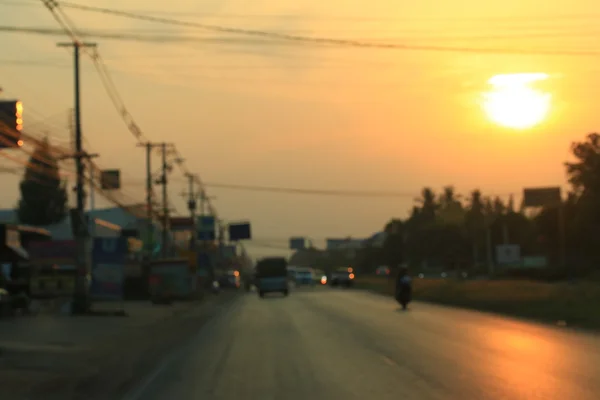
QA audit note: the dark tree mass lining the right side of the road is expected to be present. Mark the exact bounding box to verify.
[356,133,600,279]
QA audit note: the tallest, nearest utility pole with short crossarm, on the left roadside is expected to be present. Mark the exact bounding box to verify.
[58,41,96,314]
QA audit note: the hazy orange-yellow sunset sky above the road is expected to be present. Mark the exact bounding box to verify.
[0,0,600,253]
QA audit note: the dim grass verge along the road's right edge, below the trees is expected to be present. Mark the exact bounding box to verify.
[356,276,600,330]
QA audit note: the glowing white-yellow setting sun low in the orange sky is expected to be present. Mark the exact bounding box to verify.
[481,73,552,129]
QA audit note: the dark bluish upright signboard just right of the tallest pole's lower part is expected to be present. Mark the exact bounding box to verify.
[90,237,129,300]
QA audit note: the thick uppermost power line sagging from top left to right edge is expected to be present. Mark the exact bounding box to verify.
[51,2,600,56]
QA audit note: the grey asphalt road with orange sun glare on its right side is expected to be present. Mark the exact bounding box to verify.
[127,289,600,400]
